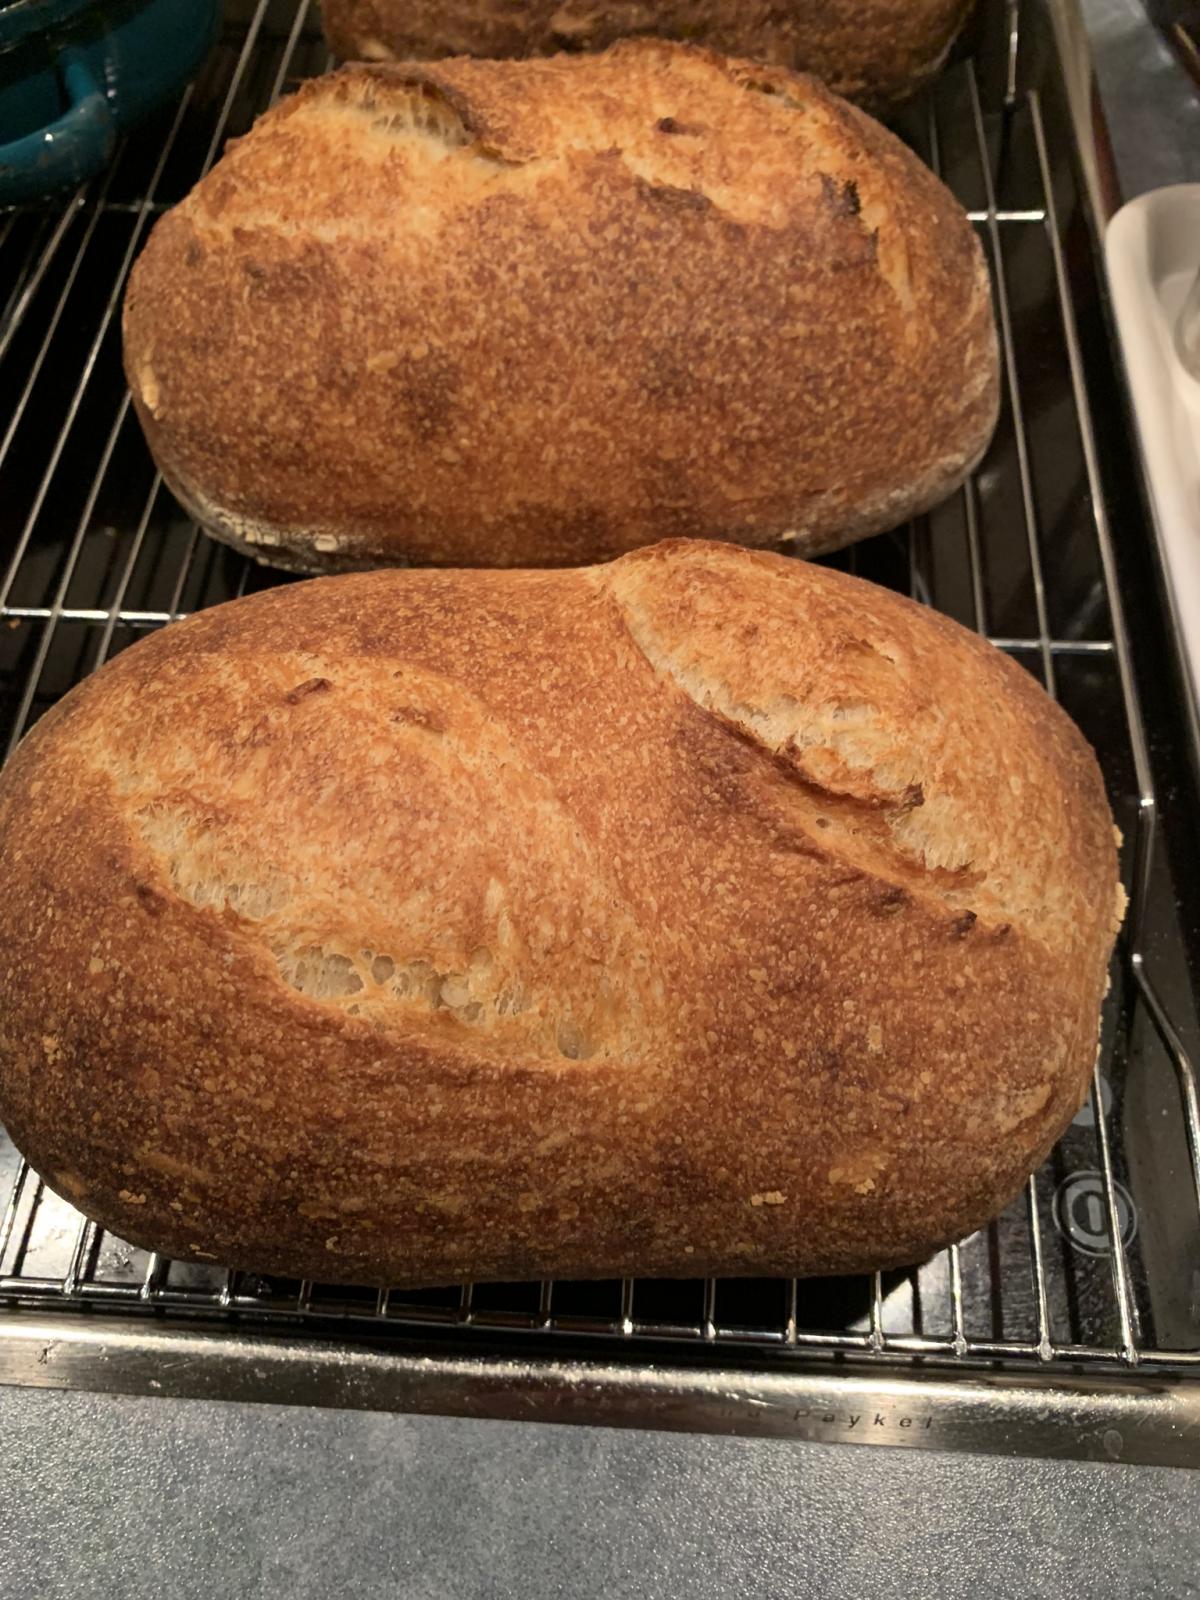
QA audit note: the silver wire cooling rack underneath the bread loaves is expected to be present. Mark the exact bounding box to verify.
[0,0,1200,1371]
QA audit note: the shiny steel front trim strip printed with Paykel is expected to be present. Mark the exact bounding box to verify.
[0,1310,1200,1469]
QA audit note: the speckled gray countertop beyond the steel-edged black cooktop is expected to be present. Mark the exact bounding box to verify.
[0,0,1200,1600]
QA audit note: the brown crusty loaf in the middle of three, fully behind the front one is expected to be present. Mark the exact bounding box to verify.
[125,42,998,571]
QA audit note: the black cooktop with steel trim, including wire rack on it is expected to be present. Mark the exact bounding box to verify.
[0,0,1200,1466]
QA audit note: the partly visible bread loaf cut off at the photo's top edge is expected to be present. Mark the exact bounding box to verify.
[322,0,971,106]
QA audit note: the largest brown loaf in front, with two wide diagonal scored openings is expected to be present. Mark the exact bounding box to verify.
[0,542,1122,1283]
